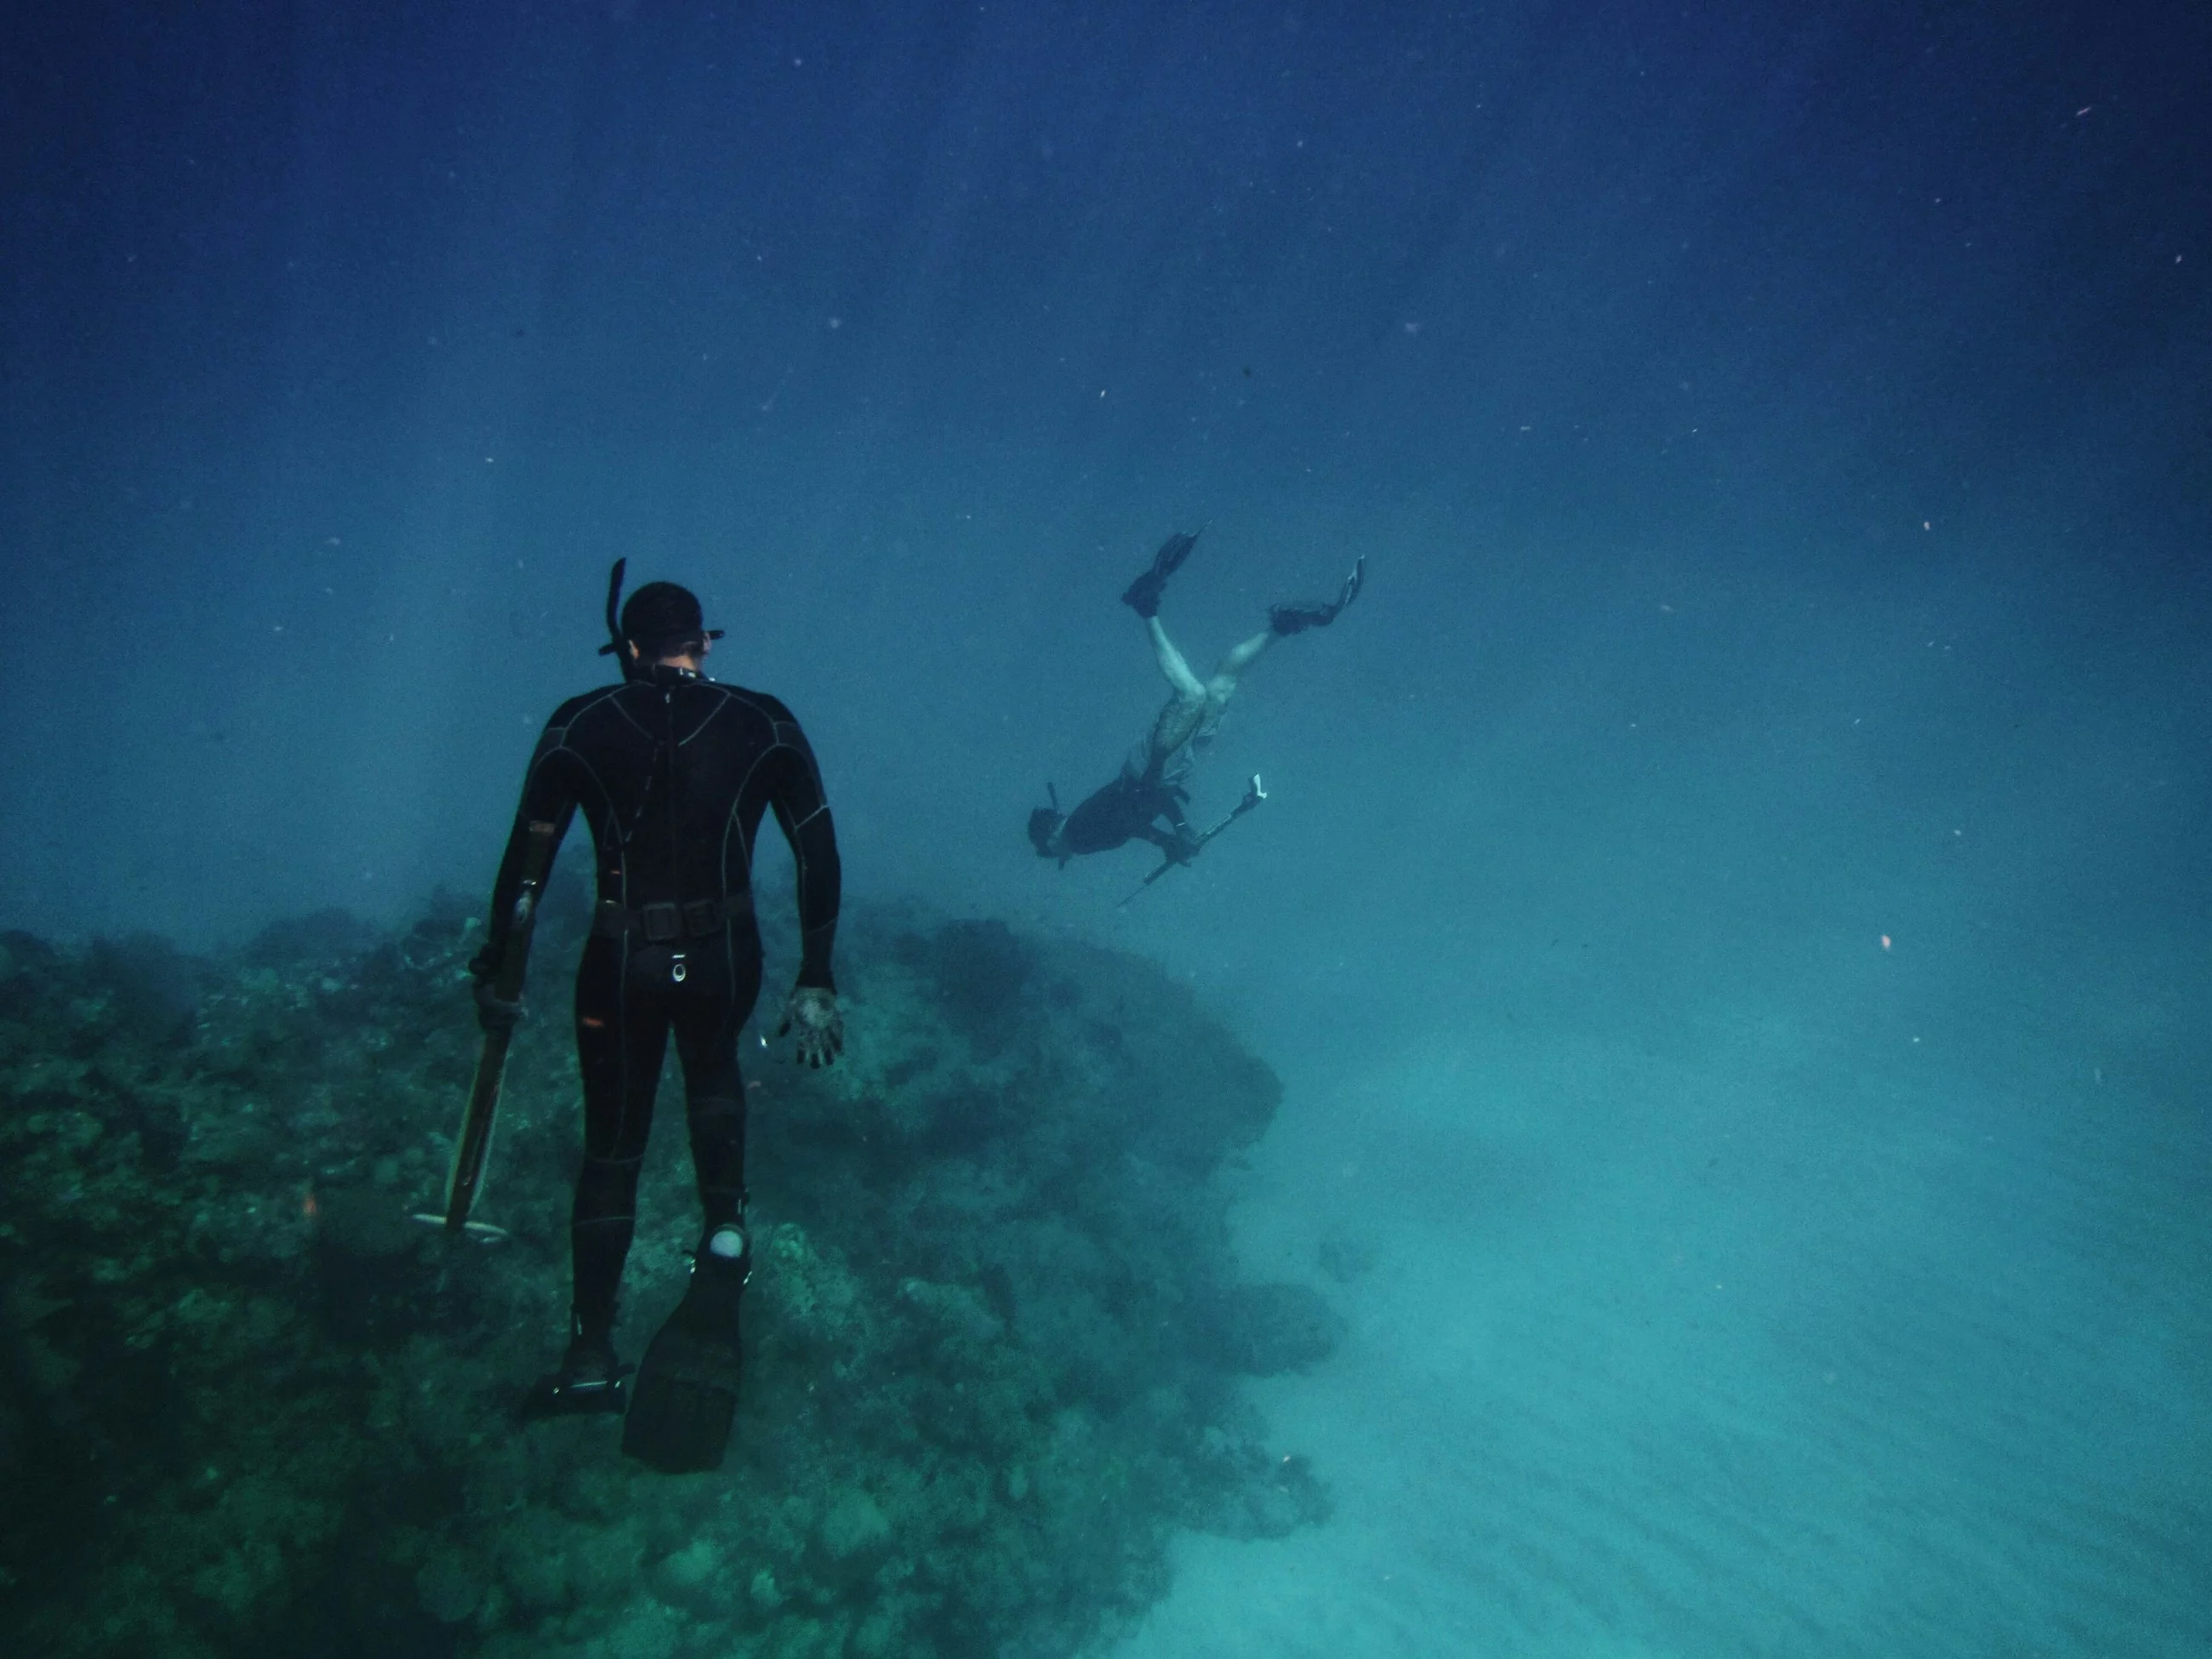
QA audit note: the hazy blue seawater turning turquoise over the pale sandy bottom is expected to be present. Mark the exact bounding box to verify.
[0,0,2212,1659]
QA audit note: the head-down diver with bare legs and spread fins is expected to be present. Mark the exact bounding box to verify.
[1029,531,1367,874]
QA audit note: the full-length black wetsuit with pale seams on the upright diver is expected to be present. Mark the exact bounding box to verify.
[476,666,838,1336]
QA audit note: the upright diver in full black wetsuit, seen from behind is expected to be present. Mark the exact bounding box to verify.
[469,562,843,1471]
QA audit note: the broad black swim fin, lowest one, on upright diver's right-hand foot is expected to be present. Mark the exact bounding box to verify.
[622,1241,752,1475]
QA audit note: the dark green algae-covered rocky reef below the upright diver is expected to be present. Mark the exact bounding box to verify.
[0,900,1338,1659]
